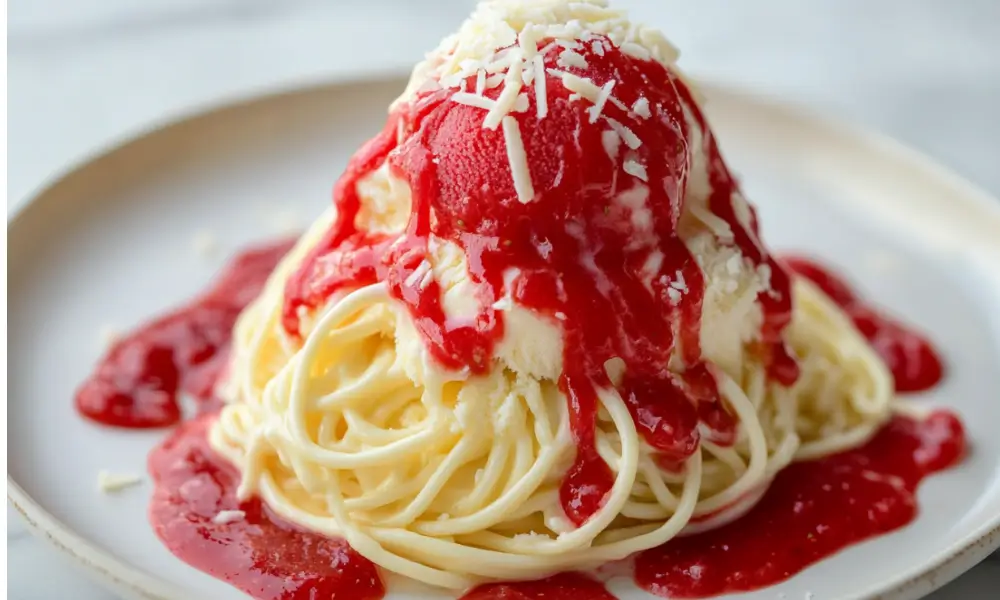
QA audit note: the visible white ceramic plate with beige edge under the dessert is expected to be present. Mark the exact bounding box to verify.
[7,80,1000,599]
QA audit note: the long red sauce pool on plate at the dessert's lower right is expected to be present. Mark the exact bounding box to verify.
[635,411,965,598]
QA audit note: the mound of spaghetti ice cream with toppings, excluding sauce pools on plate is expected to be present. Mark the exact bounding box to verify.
[209,0,893,589]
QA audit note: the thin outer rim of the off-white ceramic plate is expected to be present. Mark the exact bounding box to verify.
[7,75,1000,600]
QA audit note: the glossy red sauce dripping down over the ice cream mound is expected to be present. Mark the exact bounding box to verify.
[283,36,798,525]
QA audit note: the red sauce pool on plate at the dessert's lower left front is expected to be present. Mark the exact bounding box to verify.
[149,413,385,600]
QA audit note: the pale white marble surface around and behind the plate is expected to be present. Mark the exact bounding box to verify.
[7,0,1000,600]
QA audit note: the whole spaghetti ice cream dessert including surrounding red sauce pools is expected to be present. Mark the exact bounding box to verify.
[68,0,965,600]
